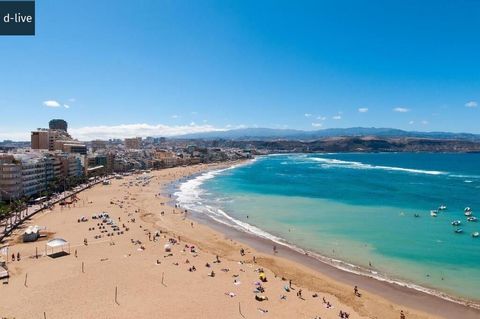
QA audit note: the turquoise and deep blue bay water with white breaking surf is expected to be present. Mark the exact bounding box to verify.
[177,153,480,301]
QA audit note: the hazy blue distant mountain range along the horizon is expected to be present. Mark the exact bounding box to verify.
[174,127,480,142]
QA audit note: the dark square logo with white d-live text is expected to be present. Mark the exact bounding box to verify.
[0,0,35,35]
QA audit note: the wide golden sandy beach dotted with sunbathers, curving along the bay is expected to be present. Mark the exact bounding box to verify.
[0,163,479,319]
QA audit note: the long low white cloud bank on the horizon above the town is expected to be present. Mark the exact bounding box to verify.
[69,123,225,141]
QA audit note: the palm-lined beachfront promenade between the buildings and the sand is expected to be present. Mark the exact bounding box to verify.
[0,175,114,242]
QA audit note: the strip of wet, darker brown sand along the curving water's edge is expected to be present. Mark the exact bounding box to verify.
[172,161,480,319]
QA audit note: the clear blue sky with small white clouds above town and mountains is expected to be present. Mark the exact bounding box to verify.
[0,0,480,139]
